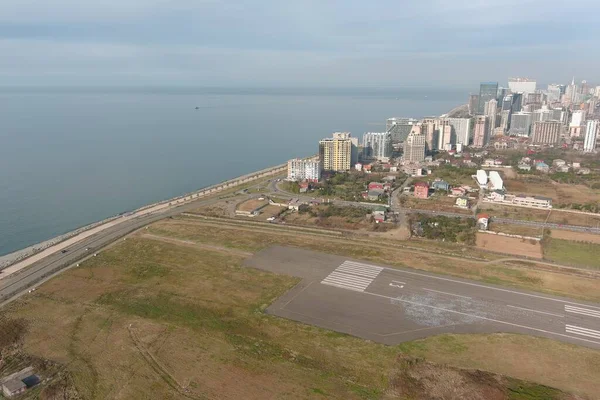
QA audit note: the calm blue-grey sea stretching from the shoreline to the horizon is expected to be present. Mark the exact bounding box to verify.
[0,89,467,255]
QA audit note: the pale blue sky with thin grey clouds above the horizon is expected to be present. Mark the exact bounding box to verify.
[0,0,600,87]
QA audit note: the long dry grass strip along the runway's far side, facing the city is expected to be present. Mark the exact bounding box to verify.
[150,220,600,301]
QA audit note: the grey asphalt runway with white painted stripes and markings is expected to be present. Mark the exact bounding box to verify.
[246,247,600,349]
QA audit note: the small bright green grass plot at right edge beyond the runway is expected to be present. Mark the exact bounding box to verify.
[544,238,600,268]
